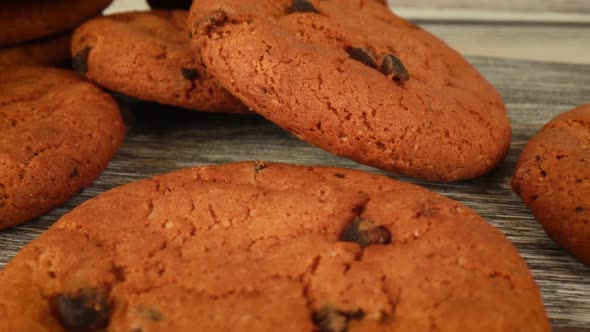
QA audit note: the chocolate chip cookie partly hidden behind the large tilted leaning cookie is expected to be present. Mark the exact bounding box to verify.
[72,10,248,112]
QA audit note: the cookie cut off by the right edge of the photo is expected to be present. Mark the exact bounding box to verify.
[512,104,590,265]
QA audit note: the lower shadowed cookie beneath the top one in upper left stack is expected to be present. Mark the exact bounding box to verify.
[0,33,72,66]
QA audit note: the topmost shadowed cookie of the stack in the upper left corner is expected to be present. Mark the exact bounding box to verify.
[0,0,112,46]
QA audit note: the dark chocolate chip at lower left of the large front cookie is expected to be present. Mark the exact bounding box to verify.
[56,289,110,332]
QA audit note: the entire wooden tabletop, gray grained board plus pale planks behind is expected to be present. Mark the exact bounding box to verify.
[0,0,590,332]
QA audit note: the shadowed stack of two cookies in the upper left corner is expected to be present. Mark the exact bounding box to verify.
[0,0,112,66]
